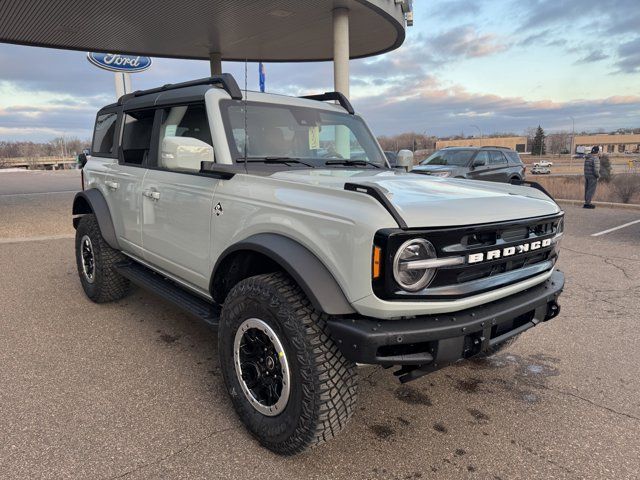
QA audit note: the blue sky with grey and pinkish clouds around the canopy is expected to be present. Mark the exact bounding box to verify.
[0,0,640,141]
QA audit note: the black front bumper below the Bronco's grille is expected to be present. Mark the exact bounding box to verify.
[328,271,564,381]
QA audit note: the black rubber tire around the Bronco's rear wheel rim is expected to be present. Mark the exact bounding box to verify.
[76,214,131,303]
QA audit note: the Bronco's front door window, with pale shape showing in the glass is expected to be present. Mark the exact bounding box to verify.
[157,104,213,172]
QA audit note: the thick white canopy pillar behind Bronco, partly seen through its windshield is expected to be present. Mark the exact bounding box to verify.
[333,8,351,158]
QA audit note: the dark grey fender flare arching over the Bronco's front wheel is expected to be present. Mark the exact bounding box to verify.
[211,233,355,315]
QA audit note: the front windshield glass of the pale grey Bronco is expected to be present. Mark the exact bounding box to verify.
[221,100,386,168]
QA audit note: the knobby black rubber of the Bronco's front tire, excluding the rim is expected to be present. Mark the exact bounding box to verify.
[218,273,358,455]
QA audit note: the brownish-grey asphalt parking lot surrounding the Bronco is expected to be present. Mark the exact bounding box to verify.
[0,171,640,479]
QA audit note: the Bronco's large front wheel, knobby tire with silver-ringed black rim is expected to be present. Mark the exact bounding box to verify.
[218,273,357,455]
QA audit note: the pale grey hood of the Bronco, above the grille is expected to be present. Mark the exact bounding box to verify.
[272,169,560,228]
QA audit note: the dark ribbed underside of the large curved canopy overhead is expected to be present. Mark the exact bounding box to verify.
[0,0,405,62]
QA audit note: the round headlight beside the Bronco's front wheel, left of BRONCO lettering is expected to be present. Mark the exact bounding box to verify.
[393,238,436,292]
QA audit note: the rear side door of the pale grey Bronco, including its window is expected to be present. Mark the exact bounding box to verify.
[105,109,155,256]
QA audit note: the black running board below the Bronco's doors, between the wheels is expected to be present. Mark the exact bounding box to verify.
[116,261,220,328]
